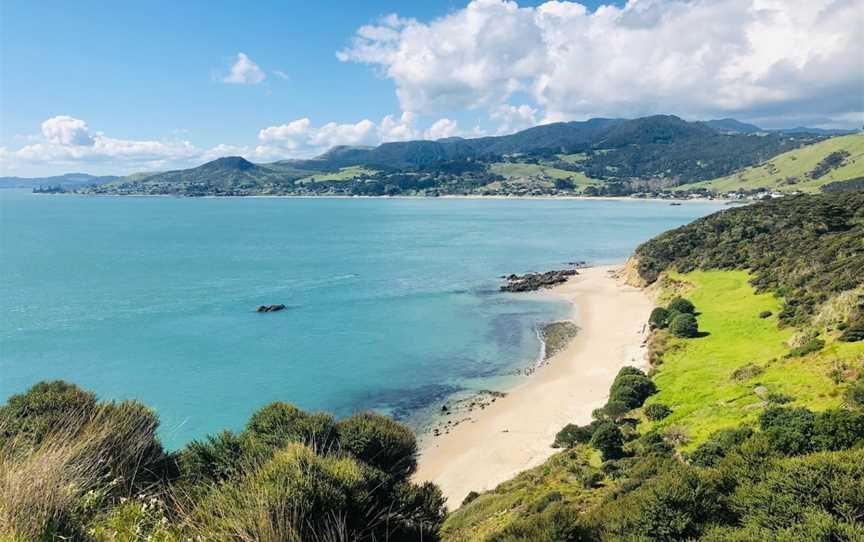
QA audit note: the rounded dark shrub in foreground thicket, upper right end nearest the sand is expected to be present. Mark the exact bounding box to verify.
[338,412,417,479]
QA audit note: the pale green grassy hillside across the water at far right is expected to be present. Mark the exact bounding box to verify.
[677,133,864,192]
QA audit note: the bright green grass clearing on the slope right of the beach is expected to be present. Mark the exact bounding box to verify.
[641,271,864,449]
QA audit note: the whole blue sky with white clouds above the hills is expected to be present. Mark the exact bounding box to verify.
[0,0,864,176]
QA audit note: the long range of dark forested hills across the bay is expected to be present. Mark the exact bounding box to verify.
[10,115,860,196]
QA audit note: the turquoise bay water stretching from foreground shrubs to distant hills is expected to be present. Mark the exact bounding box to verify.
[0,190,721,447]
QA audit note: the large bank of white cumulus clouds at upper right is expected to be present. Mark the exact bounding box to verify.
[337,0,864,129]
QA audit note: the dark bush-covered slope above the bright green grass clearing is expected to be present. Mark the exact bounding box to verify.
[636,191,864,325]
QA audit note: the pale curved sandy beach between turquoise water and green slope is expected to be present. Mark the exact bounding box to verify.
[415,266,652,509]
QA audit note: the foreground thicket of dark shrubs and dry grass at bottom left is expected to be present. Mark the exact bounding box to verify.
[0,381,444,542]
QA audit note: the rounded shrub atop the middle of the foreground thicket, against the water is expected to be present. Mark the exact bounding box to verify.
[246,401,336,452]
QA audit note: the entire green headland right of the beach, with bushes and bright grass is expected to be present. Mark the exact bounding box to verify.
[442,193,864,542]
